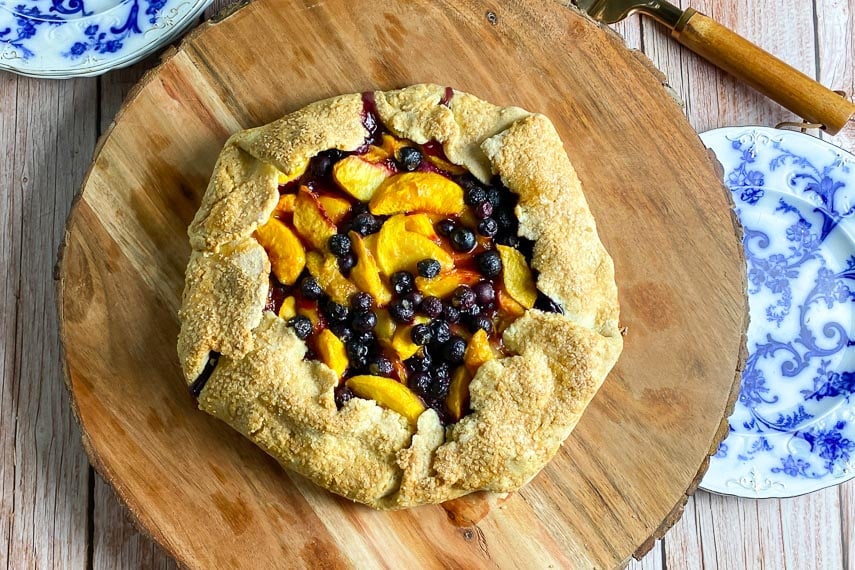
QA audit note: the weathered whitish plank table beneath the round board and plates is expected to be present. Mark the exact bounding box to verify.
[0,0,855,570]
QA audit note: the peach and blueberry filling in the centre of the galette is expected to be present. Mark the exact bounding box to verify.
[255,96,561,425]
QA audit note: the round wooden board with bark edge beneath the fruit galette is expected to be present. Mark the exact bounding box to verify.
[59,0,746,568]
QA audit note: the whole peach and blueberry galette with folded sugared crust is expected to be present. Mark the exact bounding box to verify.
[178,85,622,509]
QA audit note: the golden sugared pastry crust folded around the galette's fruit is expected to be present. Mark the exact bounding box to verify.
[178,85,622,509]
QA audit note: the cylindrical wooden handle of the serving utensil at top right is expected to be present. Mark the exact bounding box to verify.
[671,8,855,134]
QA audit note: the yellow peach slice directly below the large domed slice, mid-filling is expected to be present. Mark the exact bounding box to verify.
[377,215,454,276]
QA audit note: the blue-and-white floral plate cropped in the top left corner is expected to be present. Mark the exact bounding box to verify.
[0,0,211,79]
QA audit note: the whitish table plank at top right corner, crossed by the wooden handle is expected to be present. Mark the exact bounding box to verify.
[816,0,855,152]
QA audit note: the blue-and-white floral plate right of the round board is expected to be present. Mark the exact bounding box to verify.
[701,127,855,498]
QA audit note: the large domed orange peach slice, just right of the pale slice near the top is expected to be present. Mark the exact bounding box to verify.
[369,172,466,215]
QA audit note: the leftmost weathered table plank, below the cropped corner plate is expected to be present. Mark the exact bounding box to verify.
[0,76,96,568]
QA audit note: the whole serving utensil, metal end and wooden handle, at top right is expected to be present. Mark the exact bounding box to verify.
[571,0,855,135]
